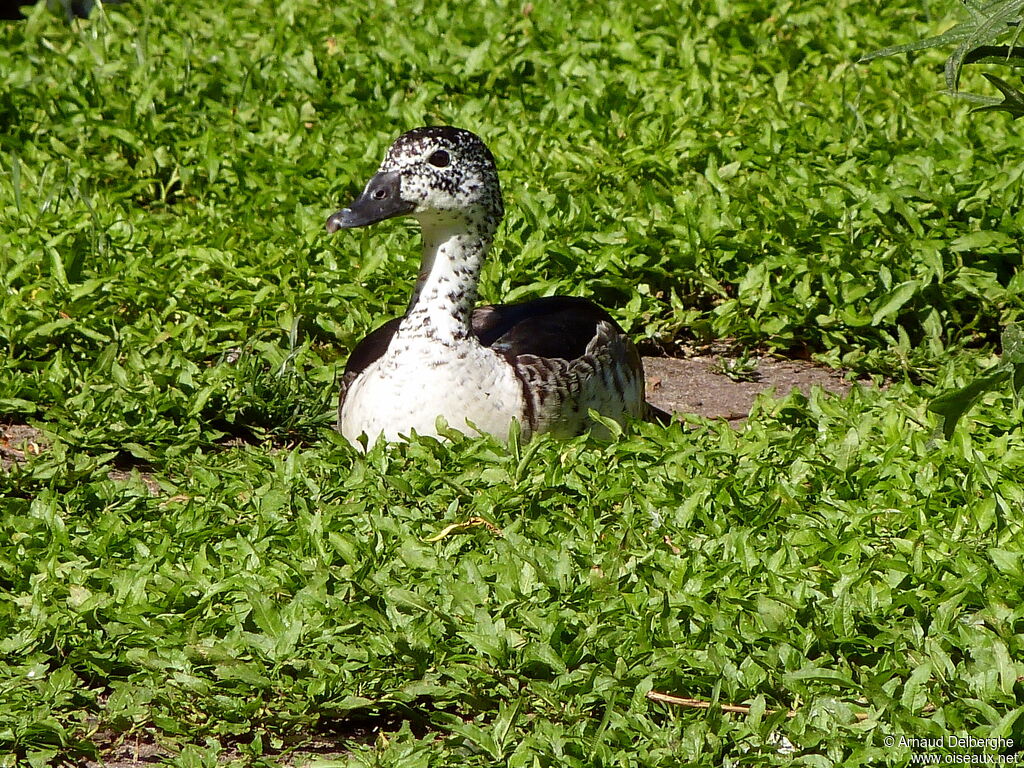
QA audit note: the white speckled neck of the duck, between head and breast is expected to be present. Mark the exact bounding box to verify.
[401,219,492,343]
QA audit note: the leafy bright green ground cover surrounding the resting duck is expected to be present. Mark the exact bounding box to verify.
[0,0,1024,766]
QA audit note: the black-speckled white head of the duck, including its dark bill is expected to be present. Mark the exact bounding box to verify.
[327,126,504,234]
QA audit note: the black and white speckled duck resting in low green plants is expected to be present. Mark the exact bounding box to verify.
[327,126,667,444]
